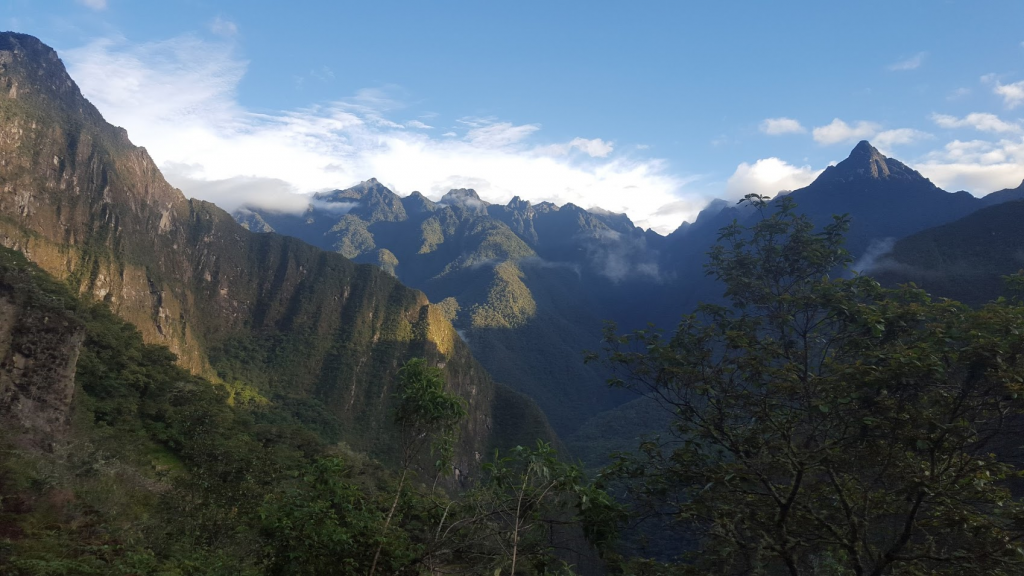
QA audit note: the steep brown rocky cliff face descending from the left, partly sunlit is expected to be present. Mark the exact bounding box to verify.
[0,33,552,465]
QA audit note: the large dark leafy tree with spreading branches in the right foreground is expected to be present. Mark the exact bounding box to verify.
[605,195,1024,576]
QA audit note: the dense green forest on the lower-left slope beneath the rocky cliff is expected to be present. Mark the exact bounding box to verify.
[0,243,608,576]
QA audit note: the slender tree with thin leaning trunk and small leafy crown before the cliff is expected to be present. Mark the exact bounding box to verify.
[370,358,466,576]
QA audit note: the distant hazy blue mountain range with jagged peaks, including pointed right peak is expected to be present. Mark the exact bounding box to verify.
[234,136,1024,454]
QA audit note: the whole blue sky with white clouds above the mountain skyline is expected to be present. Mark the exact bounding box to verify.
[6,0,1024,232]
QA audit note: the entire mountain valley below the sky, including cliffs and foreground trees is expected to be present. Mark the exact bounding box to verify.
[0,33,1024,576]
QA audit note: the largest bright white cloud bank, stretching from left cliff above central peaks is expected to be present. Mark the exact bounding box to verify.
[63,36,706,232]
